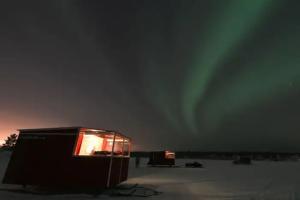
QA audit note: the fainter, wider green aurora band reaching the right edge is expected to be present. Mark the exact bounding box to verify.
[204,35,300,129]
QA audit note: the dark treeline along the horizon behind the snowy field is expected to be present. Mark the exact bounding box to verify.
[131,151,300,161]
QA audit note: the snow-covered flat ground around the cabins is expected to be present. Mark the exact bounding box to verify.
[0,152,300,200]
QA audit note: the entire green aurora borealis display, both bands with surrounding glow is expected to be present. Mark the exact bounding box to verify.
[144,0,300,138]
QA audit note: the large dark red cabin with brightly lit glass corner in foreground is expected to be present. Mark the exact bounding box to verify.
[3,127,130,188]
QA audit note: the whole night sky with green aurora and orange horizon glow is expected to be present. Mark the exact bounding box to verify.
[0,0,300,151]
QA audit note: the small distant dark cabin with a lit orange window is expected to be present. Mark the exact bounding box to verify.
[148,151,175,166]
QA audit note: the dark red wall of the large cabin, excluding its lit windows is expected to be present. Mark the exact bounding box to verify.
[3,131,129,188]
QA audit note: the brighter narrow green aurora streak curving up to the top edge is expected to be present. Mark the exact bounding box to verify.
[182,0,272,132]
